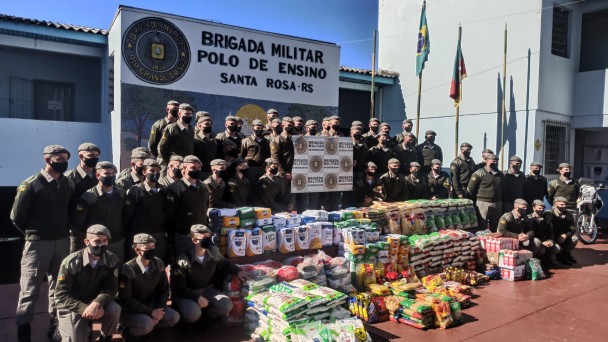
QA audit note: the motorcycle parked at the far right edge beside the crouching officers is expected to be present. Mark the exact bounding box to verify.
[576,179,605,244]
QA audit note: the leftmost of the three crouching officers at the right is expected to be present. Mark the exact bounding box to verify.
[497,198,541,255]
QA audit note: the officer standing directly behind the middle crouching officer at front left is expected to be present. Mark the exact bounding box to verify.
[125,159,167,260]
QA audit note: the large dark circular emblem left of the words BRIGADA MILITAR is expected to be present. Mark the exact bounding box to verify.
[122,17,190,84]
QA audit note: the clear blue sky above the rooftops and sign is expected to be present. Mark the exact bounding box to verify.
[0,0,378,69]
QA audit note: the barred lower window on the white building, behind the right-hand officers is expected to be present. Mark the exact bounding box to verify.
[543,120,570,175]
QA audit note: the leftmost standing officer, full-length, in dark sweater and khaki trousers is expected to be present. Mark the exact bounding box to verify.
[11,145,74,341]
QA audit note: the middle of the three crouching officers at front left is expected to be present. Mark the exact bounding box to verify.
[116,233,179,342]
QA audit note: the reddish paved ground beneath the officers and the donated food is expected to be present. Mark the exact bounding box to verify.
[0,231,608,342]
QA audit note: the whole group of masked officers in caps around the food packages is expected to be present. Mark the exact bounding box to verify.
[11,101,579,341]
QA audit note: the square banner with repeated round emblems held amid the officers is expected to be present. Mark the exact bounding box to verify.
[291,136,353,193]
